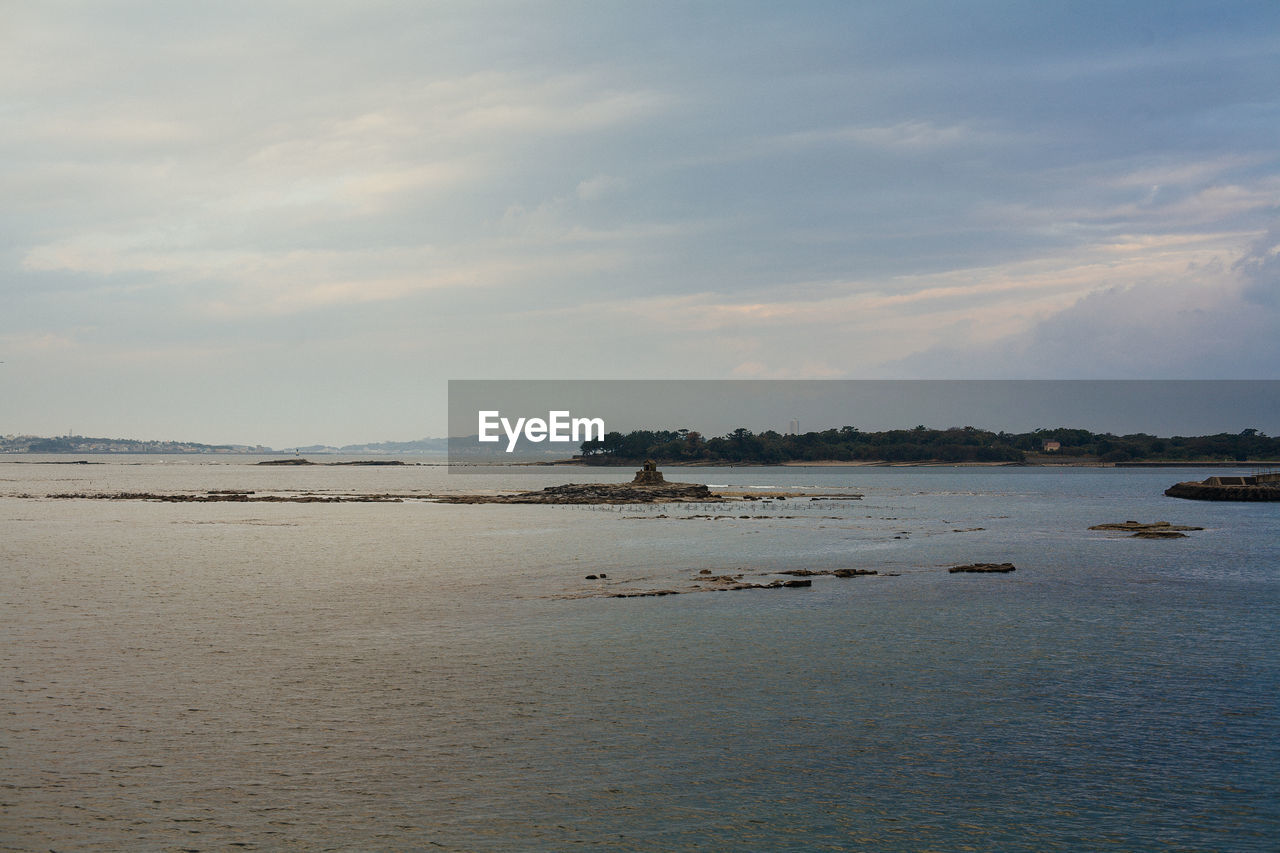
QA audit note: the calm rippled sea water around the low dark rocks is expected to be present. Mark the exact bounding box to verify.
[0,457,1280,852]
